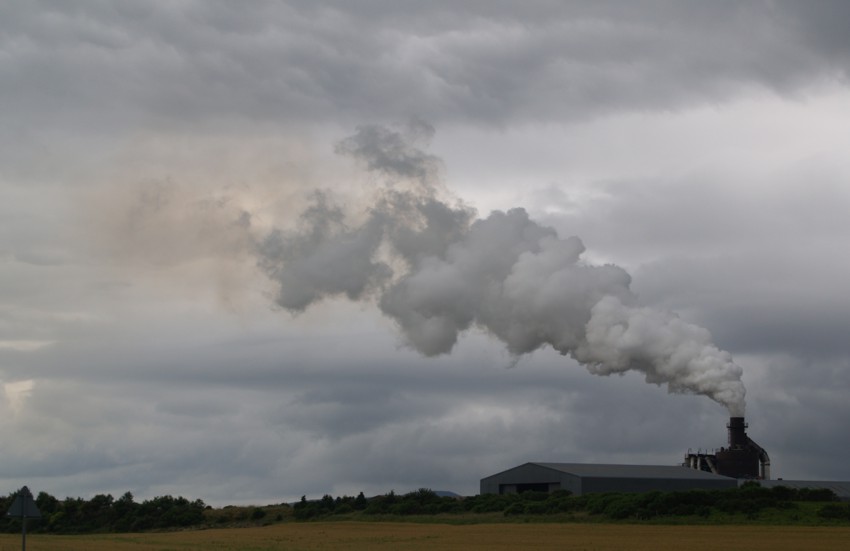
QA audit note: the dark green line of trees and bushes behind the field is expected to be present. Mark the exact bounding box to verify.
[0,483,850,534]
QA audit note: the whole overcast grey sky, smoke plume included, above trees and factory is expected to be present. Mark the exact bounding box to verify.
[0,0,850,505]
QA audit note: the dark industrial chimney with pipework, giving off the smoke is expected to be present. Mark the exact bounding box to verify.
[684,417,770,480]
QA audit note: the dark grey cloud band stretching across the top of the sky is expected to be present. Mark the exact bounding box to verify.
[0,1,848,133]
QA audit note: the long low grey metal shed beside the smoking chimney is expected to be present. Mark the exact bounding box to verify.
[481,463,738,495]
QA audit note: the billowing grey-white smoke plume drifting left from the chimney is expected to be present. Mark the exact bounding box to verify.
[258,122,745,416]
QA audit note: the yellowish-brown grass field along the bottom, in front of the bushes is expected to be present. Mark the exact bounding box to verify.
[0,522,850,551]
